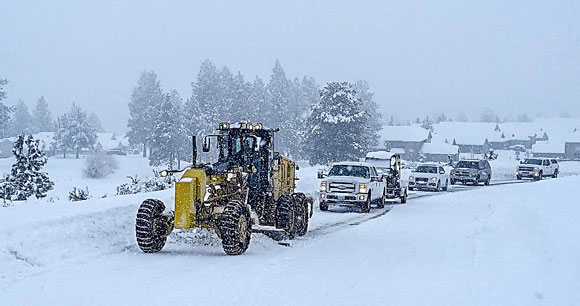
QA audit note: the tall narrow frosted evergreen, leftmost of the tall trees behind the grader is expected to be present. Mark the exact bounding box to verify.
[127,71,164,157]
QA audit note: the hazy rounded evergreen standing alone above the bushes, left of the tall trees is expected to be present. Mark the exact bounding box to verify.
[54,103,97,159]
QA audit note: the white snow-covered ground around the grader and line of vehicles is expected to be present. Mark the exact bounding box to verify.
[0,154,580,305]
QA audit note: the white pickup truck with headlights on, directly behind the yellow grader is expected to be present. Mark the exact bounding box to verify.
[318,162,386,213]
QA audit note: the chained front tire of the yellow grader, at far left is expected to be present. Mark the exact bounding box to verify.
[135,199,173,253]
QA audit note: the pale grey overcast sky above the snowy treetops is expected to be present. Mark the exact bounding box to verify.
[0,0,580,131]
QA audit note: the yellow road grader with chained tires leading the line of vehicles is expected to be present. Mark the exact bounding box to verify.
[135,122,313,255]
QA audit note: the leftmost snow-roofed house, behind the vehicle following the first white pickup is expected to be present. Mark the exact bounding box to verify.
[377,125,432,160]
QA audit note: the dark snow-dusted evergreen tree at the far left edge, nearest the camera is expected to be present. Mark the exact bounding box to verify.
[0,134,54,201]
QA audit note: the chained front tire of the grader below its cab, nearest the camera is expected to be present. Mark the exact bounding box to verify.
[219,201,252,255]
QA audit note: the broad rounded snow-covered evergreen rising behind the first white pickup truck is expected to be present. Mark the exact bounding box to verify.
[306,82,370,165]
